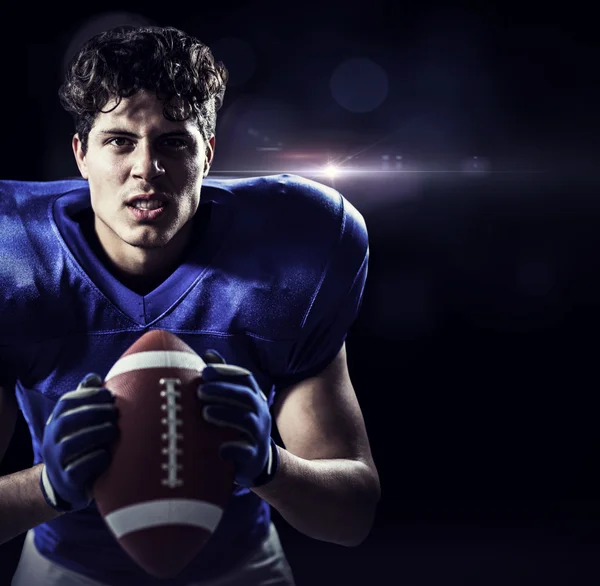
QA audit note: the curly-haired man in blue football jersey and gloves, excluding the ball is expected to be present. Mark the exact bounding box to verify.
[0,27,380,586]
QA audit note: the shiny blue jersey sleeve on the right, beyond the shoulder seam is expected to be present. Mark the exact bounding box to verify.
[275,198,369,390]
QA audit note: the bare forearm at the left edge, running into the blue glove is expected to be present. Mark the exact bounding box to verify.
[0,464,62,544]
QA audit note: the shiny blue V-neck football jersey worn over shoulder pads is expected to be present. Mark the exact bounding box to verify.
[0,175,369,586]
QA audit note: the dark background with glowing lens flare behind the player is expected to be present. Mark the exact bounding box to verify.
[0,1,600,586]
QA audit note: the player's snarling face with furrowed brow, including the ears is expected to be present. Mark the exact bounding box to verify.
[73,92,214,256]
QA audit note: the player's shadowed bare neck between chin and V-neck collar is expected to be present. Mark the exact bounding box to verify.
[94,217,192,295]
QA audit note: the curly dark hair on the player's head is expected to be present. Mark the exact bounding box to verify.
[58,26,229,152]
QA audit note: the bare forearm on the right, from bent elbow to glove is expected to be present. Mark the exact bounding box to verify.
[252,447,379,546]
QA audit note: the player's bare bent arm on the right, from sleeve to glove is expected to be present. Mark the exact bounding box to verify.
[252,346,381,546]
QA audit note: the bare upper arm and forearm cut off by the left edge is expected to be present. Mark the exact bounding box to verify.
[0,387,60,544]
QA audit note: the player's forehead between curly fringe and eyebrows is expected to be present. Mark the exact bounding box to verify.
[92,91,200,134]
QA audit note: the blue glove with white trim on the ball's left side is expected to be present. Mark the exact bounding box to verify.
[40,374,118,512]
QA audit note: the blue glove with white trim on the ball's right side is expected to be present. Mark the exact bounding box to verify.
[198,350,279,488]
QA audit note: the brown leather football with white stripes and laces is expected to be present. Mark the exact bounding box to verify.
[93,330,238,578]
